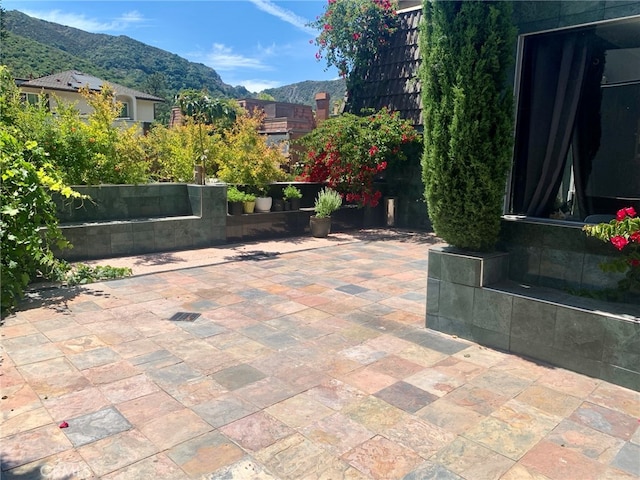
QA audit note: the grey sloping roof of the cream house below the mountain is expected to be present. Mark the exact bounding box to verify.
[20,70,164,102]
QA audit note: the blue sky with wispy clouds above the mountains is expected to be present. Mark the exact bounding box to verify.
[2,0,338,92]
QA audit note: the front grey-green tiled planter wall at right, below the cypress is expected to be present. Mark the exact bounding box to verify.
[426,236,640,391]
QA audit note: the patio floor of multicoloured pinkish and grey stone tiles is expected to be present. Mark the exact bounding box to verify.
[0,230,640,480]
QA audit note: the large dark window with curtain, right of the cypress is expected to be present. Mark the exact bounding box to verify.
[509,17,640,221]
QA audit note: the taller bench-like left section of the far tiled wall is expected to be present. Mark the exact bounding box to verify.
[55,183,227,261]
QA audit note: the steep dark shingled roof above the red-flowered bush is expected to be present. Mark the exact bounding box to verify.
[346,7,422,126]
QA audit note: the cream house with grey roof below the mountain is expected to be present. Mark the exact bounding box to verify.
[16,70,164,130]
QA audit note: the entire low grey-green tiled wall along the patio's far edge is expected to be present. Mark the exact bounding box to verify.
[54,183,384,261]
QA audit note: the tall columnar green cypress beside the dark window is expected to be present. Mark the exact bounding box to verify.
[420,0,515,251]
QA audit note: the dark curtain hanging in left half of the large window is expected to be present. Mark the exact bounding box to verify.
[512,31,592,217]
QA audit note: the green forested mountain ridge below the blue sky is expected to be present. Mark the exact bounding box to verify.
[0,9,345,112]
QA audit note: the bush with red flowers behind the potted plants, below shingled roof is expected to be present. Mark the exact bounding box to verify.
[298,109,417,206]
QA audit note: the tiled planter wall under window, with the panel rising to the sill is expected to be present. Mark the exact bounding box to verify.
[426,220,640,391]
